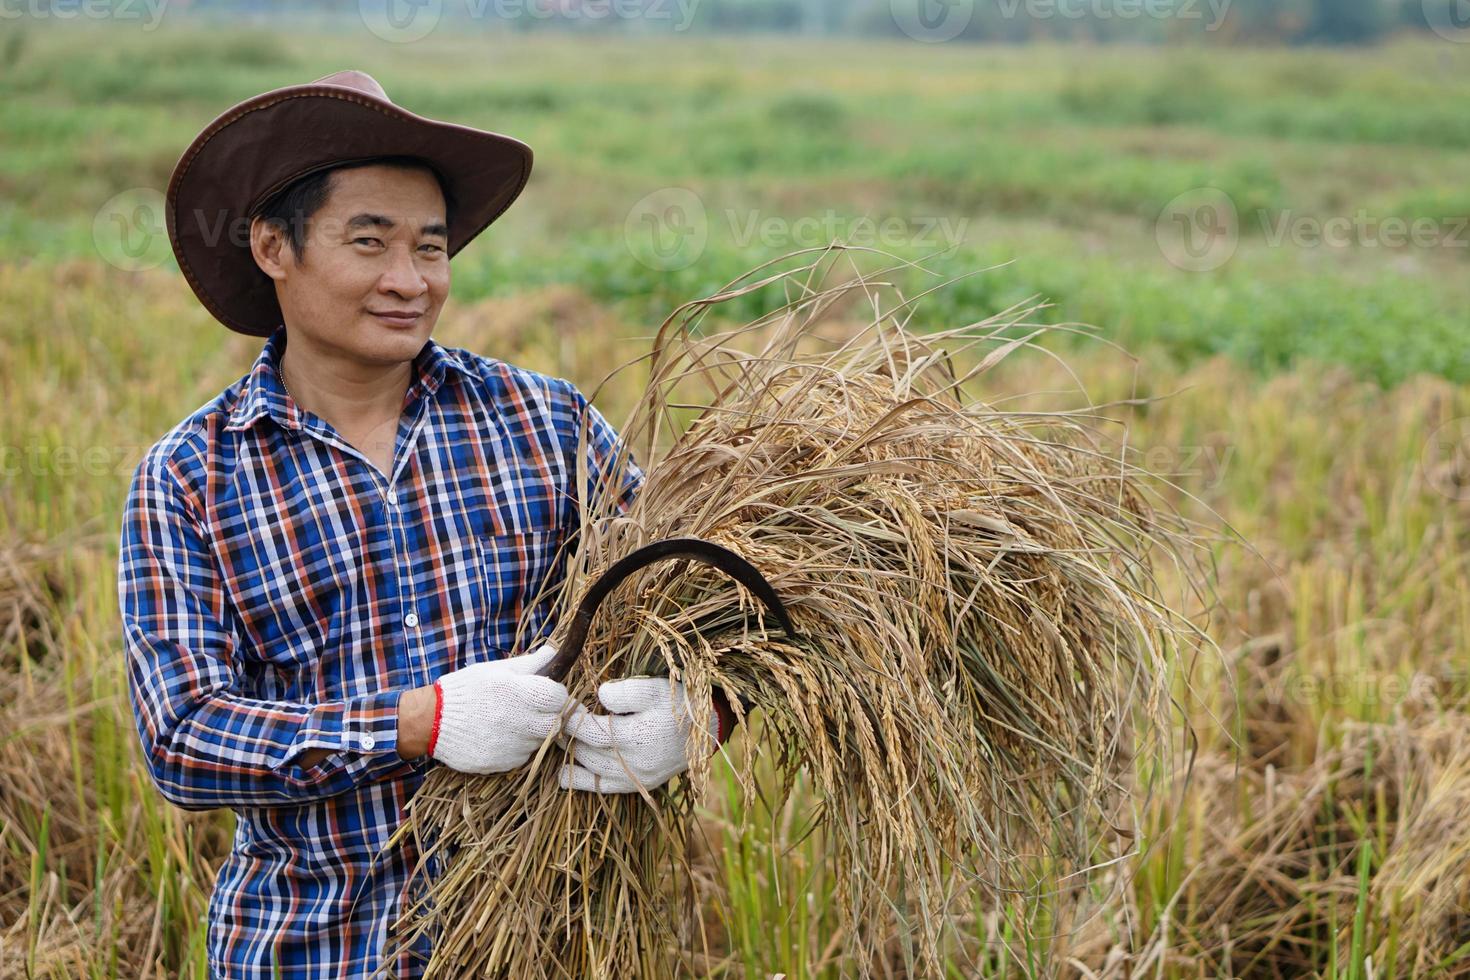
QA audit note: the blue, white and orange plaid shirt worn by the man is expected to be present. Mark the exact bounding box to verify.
[119,328,642,979]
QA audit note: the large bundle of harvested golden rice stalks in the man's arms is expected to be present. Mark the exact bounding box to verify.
[400,245,1200,980]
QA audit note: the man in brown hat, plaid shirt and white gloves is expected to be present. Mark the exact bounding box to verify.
[119,72,731,979]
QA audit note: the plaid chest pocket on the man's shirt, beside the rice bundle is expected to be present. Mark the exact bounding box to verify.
[478,529,566,657]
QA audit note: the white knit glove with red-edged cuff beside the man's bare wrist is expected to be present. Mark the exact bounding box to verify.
[429,644,573,773]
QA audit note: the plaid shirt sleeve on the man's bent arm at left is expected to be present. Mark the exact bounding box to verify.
[118,457,406,810]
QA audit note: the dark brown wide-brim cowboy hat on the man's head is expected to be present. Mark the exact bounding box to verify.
[165,71,532,336]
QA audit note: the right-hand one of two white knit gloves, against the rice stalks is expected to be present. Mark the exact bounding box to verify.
[557,677,719,793]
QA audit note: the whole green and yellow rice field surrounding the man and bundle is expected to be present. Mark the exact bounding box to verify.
[0,16,1470,979]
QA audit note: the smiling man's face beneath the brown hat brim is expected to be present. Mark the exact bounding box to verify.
[253,165,450,366]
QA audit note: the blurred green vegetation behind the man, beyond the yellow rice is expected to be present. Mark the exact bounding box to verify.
[0,18,1470,383]
